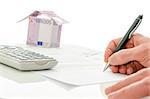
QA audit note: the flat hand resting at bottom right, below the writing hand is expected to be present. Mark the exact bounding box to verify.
[105,68,150,99]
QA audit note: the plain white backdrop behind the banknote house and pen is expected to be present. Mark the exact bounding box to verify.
[0,0,150,98]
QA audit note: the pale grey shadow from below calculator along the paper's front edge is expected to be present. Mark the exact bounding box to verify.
[0,64,77,90]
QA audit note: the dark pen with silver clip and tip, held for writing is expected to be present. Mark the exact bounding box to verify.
[103,15,143,72]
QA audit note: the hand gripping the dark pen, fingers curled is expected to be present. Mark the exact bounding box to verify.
[104,34,150,74]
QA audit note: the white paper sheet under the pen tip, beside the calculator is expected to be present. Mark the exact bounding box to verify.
[23,46,126,85]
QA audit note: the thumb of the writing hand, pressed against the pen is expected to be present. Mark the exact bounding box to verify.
[108,48,136,65]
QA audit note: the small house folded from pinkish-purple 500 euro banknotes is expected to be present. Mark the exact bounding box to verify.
[18,11,67,47]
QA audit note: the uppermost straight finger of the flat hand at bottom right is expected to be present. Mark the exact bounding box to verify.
[105,68,150,94]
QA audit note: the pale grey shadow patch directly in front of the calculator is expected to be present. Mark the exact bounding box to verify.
[0,64,45,83]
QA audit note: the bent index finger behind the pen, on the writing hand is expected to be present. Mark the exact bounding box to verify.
[104,38,121,62]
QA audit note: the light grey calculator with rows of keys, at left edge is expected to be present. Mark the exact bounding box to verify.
[0,45,58,71]
